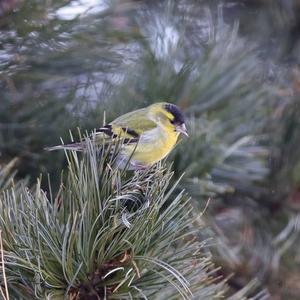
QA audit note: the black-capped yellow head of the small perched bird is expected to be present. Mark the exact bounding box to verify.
[150,102,188,136]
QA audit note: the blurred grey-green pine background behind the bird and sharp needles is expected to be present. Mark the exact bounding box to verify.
[0,0,300,300]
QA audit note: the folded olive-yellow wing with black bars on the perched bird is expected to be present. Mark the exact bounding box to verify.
[95,109,157,141]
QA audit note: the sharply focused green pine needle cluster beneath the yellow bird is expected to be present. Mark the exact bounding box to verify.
[0,144,224,299]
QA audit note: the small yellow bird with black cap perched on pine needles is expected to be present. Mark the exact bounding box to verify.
[46,102,188,170]
